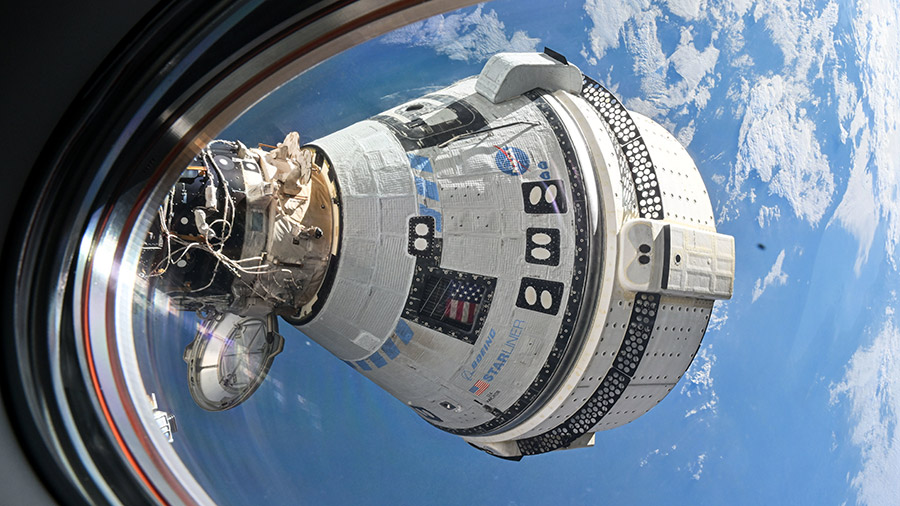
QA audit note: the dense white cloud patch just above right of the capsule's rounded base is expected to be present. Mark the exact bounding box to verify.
[726,75,834,225]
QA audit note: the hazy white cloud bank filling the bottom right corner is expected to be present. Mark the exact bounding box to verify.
[830,314,900,504]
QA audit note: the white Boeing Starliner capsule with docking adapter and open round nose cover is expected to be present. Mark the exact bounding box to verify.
[141,50,734,459]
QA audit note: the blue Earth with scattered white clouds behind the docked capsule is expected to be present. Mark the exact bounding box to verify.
[148,0,900,504]
